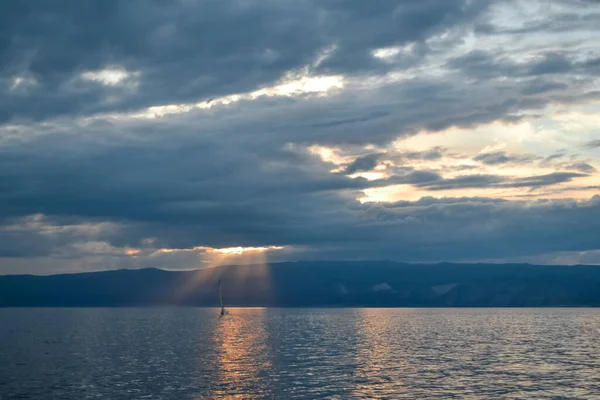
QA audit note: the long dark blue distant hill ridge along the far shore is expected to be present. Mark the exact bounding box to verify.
[0,261,600,307]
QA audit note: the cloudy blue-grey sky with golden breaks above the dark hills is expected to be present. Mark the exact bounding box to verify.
[0,0,600,274]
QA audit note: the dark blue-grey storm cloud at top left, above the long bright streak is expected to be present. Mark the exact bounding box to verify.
[0,0,489,120]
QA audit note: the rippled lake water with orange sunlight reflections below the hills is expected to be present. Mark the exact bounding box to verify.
[0,308,600,400]
